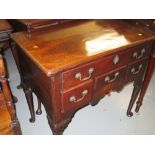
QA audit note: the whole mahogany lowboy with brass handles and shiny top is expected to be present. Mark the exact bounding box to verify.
[12,20,155,134]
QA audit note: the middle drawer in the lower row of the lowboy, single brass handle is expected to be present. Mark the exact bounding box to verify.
[95,67,127,97]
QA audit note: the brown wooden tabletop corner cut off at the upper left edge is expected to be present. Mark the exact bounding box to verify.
[0,19,12,33]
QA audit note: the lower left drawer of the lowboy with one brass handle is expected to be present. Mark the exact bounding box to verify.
[61,80,93,112]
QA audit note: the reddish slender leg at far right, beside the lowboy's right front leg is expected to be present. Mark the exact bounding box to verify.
[135,54,155,112]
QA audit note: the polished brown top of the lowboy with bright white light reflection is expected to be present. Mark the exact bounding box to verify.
[11,20,155,76]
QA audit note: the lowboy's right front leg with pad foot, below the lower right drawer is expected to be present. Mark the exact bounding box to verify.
[127,83,140,117]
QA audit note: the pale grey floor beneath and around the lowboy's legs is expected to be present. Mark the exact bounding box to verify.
[5,50,155,135]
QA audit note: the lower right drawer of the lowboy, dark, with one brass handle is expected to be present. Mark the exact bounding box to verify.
[127,59,148,82]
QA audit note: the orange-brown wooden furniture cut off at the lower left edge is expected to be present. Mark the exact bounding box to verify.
[0,55,21,135]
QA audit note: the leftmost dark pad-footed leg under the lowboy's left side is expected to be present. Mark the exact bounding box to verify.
[23,88,35,123]
